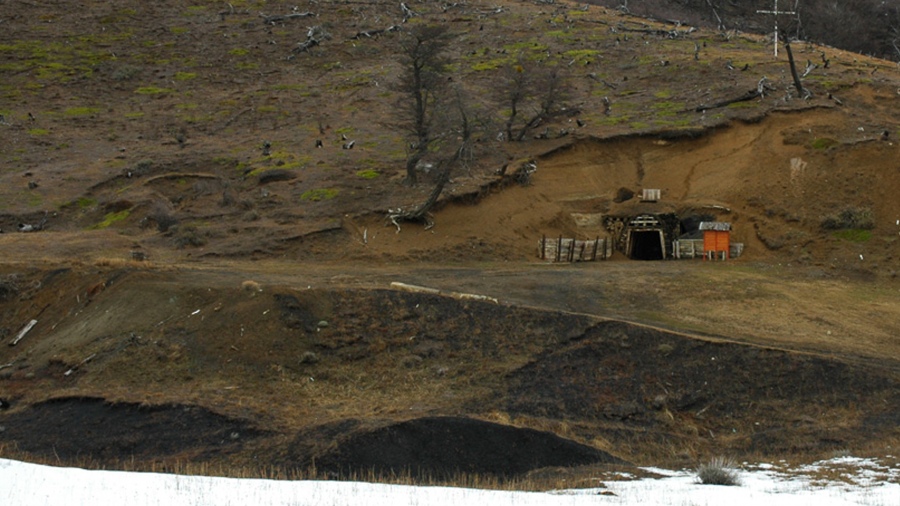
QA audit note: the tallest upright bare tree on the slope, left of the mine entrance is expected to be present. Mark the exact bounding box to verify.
[397,25,452,186]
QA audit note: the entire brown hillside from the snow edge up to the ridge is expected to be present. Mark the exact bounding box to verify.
[0,1,900,484]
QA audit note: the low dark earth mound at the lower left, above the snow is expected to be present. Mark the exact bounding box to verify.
[0,397,261,461]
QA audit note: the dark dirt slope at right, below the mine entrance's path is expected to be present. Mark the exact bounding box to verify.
[507,322,900,454]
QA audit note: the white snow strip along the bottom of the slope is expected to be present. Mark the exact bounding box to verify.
[0,456,900,506]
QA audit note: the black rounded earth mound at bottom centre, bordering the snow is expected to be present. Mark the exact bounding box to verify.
[316,417,622,479]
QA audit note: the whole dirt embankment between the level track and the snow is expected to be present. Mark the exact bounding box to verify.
[0,269,900,476]
